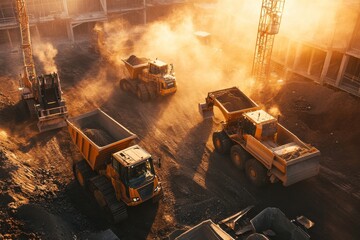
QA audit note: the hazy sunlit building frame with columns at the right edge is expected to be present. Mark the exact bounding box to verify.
[272,0,360,96]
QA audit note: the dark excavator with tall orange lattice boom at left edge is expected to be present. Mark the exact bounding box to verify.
[16,0,68,132]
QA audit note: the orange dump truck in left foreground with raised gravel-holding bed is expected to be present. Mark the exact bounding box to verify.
[67,109,162,223]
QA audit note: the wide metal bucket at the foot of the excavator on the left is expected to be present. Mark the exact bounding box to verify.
[37,106,68,132]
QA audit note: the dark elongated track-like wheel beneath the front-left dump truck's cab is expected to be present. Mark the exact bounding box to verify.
[89,176,128,224]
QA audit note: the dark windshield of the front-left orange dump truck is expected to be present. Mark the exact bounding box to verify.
[128,159,155,187]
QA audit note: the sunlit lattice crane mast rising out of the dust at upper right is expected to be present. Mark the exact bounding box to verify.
[252,0,285,83]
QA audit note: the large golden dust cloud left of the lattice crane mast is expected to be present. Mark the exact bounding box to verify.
[95,1,260,97]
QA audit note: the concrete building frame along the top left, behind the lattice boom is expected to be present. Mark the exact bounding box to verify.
[0,0,183,45]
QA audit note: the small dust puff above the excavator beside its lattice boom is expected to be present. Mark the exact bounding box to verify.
[33,42,58,73]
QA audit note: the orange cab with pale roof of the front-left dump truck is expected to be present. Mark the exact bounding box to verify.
[108,145,162,206]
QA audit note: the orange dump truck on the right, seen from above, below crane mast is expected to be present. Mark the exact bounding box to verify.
[199,87,320,186]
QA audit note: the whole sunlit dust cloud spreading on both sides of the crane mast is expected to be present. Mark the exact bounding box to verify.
[96,0,355,124]
